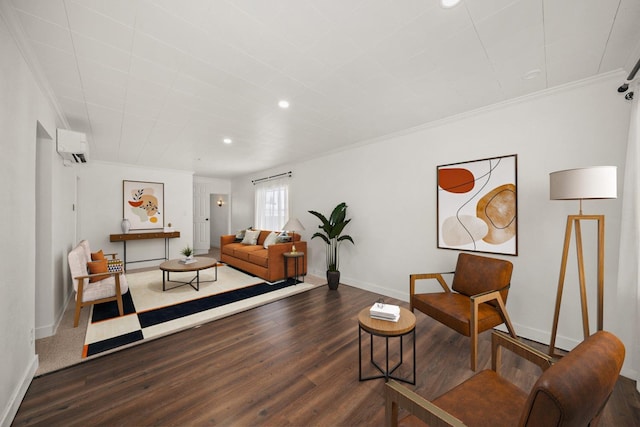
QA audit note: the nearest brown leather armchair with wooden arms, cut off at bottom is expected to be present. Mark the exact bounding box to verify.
[385,331,625,427]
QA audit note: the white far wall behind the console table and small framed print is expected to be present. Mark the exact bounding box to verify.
[77,161,193,269]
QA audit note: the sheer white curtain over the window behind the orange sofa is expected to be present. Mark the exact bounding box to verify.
[254,177,289,231]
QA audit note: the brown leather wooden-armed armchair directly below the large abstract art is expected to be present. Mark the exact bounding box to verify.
[409,253,517,371]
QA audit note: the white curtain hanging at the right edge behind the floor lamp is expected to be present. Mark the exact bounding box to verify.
[617,83,640,391]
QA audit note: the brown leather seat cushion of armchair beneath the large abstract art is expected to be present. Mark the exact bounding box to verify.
[411,292,503,337]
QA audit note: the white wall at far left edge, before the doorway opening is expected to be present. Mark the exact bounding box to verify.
[0,10,57,425]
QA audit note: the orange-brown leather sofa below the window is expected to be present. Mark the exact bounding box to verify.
[220,230,307,282]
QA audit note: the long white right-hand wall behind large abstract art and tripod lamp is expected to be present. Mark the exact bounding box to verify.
[232,74,635,378]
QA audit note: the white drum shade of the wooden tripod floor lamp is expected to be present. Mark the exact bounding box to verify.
[549,166,618,200]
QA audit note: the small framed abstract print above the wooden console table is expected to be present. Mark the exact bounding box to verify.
[122,181,164,230]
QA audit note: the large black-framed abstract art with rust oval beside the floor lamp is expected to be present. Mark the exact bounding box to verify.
[437,154,518,255]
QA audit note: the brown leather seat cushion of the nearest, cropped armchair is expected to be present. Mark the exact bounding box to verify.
[433,370,527,427]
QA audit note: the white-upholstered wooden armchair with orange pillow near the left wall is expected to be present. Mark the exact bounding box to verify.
[67,240,129,328]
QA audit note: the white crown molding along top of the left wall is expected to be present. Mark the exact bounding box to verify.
[0,0,69,129]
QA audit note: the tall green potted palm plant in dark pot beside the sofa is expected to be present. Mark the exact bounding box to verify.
[309,202,355,289]
